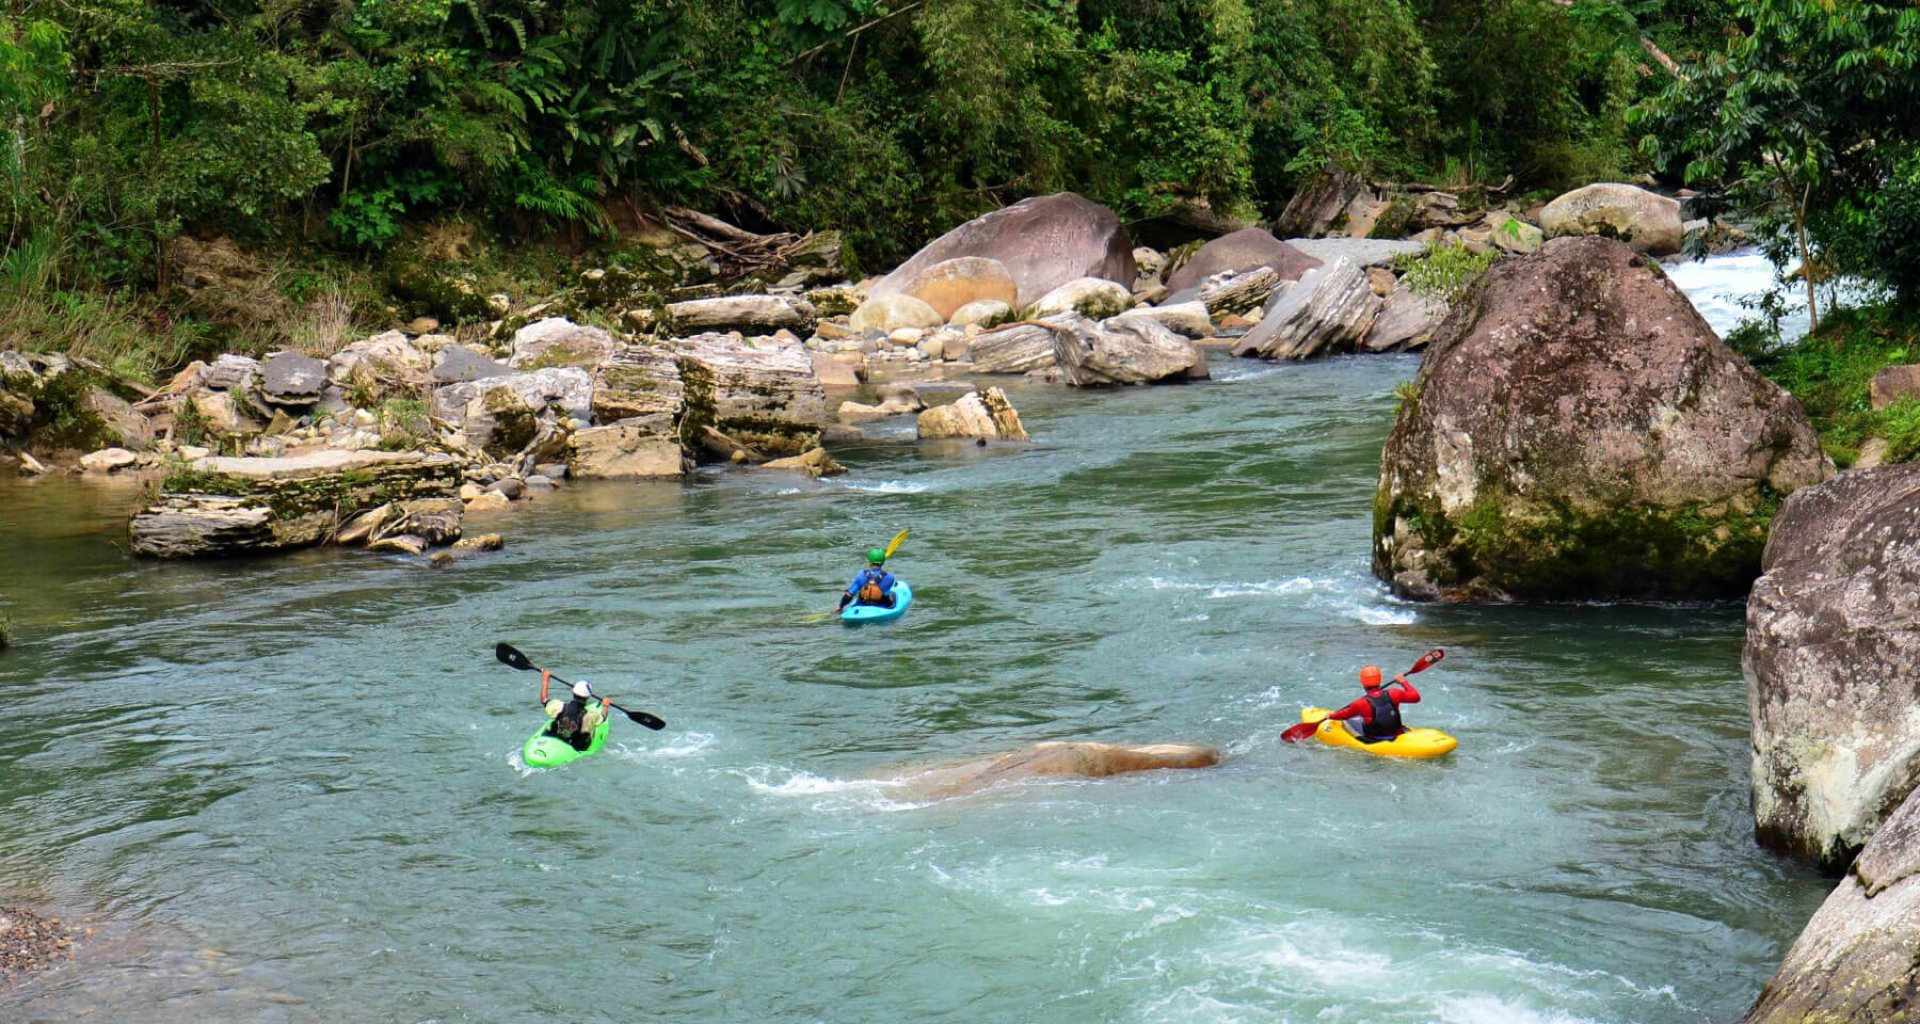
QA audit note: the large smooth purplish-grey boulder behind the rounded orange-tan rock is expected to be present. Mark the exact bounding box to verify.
[868,192,1135,305]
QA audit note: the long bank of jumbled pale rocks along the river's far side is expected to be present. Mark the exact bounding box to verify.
[0,175,1728,557]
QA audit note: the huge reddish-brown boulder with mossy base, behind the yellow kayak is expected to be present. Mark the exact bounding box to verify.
[1373,238,1834,599]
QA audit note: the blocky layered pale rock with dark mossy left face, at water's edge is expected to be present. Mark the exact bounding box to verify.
[676,334,828,455]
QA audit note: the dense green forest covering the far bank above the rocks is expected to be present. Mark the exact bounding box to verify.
[0,0,1743,330]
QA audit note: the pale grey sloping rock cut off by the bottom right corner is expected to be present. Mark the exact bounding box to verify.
[1740,783,1920,1024]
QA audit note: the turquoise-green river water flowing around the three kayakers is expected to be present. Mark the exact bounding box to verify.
[0,259,1830,1024]
